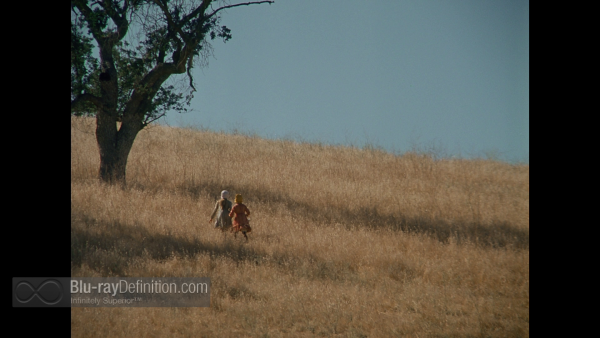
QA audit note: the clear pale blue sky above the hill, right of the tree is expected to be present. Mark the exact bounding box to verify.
[163,0,529,163]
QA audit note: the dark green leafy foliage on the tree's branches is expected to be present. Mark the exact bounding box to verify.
[71,0,237,124]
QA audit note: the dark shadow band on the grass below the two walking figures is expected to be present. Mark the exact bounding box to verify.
[71,211,368,282]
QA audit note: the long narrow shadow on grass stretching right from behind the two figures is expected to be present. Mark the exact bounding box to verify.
[178,182,529,249]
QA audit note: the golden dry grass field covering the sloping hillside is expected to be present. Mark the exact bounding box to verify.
[71,118,529,337]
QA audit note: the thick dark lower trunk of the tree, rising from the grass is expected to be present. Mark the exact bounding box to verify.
[96,111,142,187]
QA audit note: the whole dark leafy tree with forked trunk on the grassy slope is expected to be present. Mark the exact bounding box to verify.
[71,0,274,185]
